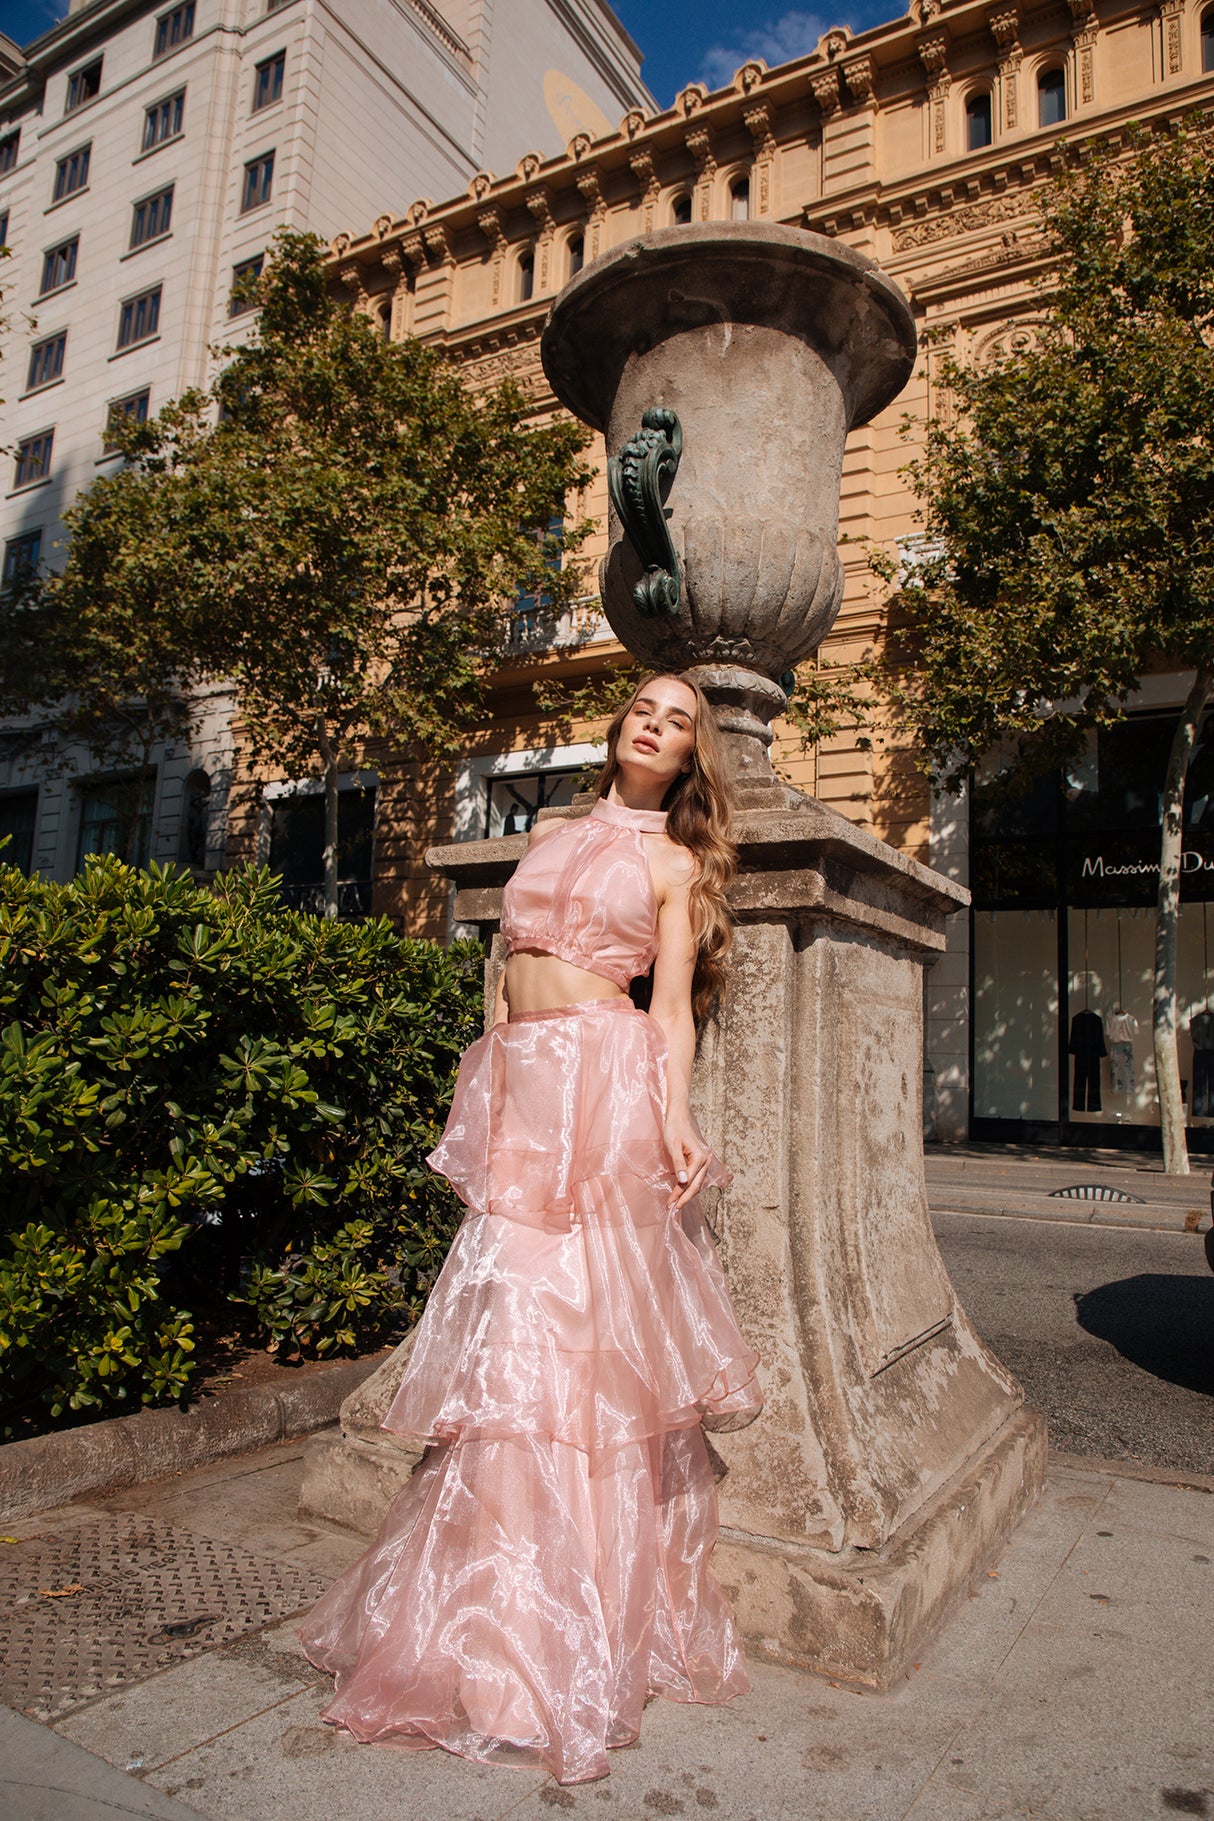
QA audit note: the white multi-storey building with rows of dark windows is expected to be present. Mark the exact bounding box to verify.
[0,0,652,878]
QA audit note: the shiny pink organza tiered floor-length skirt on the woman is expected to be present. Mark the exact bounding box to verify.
[302,1000,761,1783]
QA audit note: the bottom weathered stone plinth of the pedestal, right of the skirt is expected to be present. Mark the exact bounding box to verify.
[712,1408,1047,1692]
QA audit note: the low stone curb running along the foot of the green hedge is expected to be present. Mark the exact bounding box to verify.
[0,1351,388,1524]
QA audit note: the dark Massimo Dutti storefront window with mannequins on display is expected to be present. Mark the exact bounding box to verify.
[970,716,1214,1149]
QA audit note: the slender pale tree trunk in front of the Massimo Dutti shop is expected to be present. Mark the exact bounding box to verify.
[1152,665,1214,1176]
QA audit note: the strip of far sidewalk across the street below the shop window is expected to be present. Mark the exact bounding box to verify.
[925,1144,1214,1230]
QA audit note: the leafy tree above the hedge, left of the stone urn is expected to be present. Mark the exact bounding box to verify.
[0,233,588,916]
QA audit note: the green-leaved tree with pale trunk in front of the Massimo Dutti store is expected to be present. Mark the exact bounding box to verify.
[894,129,1214,1173]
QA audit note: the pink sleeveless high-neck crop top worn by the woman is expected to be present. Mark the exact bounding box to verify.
[502,798,666,989]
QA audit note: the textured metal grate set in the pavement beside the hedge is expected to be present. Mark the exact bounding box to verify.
[0,1511,328,1721]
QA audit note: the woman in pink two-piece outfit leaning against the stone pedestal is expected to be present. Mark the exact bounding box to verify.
[302,676,761,1783]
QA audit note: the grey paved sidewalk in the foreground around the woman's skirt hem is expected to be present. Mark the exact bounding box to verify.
[0,1442,1214,1821]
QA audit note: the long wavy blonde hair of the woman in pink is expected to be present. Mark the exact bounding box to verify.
[595,670,737,1023]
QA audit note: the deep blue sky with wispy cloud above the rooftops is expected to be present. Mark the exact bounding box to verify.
[0,0,903,107]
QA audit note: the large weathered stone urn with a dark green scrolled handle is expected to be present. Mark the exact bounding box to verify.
[542,222,916,785]
